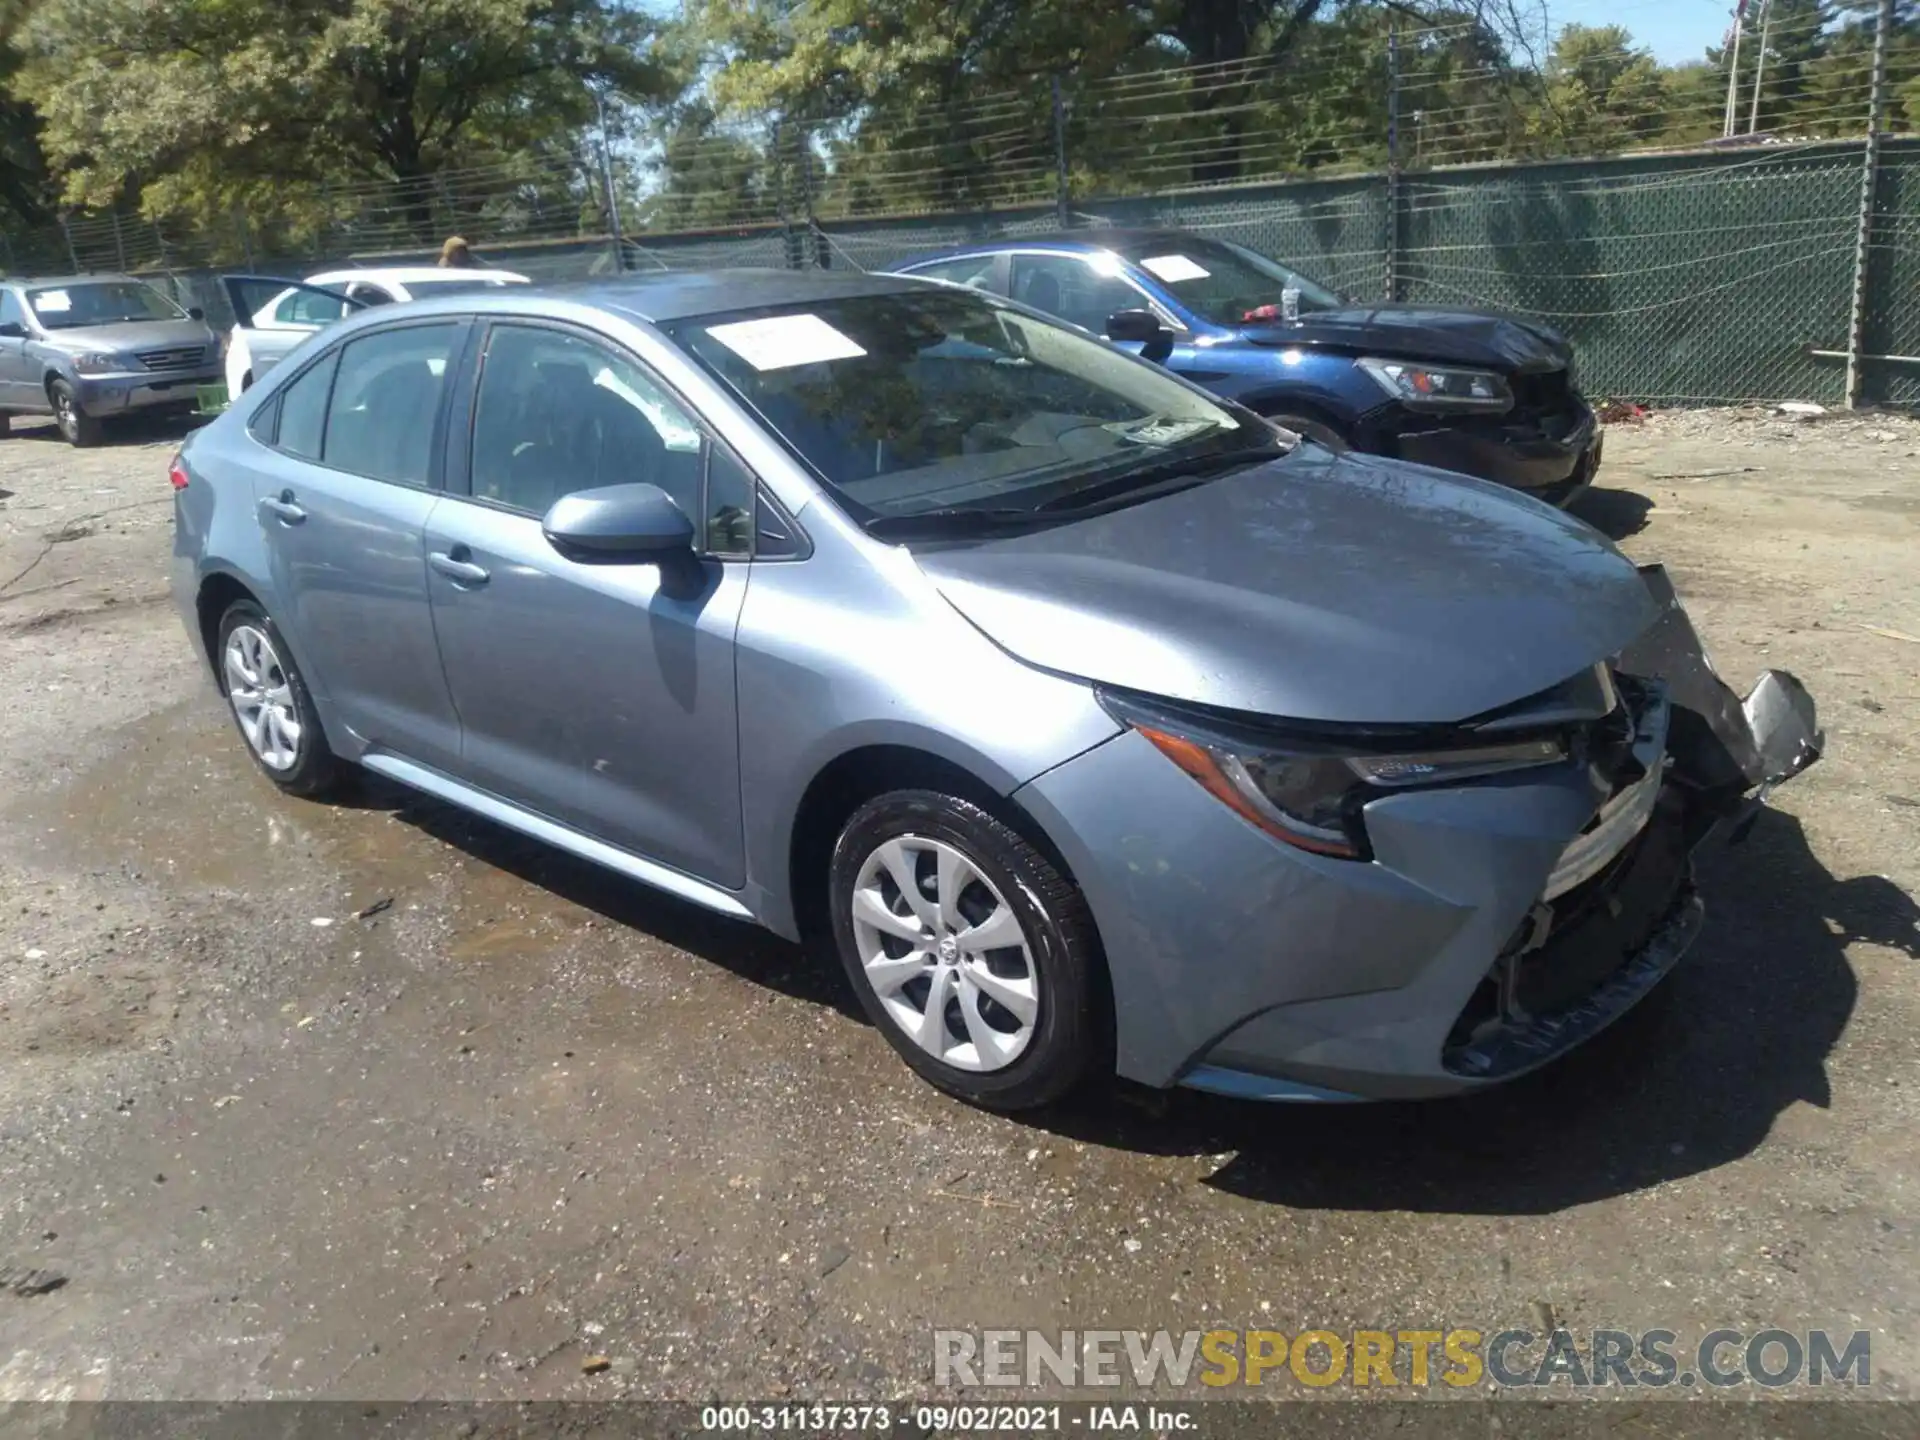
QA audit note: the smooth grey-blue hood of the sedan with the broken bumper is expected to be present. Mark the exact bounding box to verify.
[916,447,1659,724]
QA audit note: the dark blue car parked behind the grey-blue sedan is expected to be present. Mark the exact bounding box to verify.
[895,230,1601,505]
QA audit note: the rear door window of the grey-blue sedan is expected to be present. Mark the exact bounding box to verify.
[322,323,461,486]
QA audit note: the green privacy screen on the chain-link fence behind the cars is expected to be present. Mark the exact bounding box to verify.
[15,138,1920,405]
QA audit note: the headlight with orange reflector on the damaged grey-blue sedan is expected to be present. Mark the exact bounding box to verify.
[1100,693,1569,860]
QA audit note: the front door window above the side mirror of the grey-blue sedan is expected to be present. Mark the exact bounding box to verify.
[472,324,703,522]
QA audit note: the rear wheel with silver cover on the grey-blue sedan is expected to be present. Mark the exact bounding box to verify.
[213,601,344,797]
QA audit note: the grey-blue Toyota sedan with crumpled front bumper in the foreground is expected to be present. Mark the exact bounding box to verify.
[171,271,1818,1108]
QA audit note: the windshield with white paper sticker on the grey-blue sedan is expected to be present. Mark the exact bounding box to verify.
[668,286,1283,532]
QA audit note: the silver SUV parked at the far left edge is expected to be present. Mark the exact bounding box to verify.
[0,275,221,445]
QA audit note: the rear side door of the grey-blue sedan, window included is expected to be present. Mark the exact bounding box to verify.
[253,321,467,768]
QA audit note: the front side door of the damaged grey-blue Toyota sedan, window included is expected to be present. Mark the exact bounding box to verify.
[426,323,747,889]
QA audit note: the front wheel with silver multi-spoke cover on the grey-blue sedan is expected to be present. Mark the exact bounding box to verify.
[828,789,1110,1110]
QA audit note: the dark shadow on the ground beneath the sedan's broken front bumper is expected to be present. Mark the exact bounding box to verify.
[1048,810,1920,1215]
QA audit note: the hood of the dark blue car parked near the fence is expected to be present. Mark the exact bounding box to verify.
[1242,305,1572,371]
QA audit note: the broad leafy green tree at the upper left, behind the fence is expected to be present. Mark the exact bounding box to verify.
[17,0,664,242]
